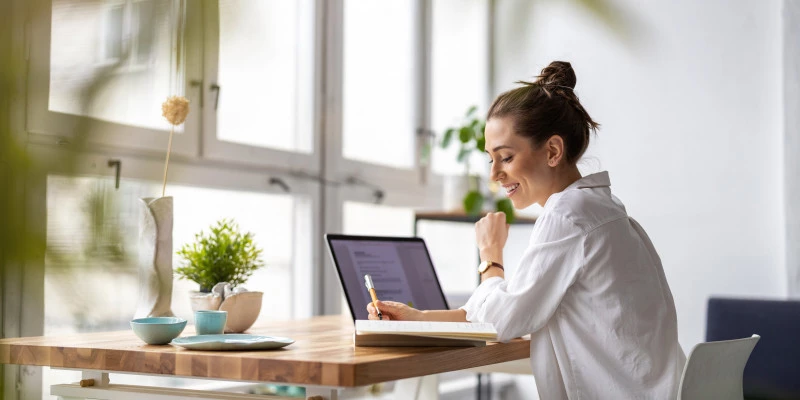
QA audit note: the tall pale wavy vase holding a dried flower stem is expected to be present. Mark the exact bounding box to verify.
[135,197,175,318]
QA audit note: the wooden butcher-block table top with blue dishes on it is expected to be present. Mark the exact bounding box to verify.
[0,316,530,387]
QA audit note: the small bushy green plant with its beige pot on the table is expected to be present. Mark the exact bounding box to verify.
[175,219,264,332]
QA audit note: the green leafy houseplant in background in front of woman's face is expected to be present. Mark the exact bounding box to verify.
[440,106,514,223]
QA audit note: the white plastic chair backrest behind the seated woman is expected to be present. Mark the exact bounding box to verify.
[678,335,761,400]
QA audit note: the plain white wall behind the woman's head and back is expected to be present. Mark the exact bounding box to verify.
[494,0,787,352]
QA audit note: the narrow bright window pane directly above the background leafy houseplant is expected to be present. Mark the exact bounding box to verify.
[431,0,489,174]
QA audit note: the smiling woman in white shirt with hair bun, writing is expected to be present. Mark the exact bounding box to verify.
[368,61,686,399]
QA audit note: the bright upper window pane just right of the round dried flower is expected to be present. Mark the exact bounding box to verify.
[217,0,314,153]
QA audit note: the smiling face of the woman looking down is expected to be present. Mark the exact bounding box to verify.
[484,118,554,209]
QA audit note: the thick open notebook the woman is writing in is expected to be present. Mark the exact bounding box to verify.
[353,320,497,347]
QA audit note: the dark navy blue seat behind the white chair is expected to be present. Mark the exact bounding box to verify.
[706,298,800,400]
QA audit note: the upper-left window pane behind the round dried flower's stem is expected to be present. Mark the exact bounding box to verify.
[49,0,183,130]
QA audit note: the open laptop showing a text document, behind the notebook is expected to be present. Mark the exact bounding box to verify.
[325,234,449,320]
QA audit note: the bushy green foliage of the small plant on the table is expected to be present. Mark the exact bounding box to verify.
[175,219,264,292]
